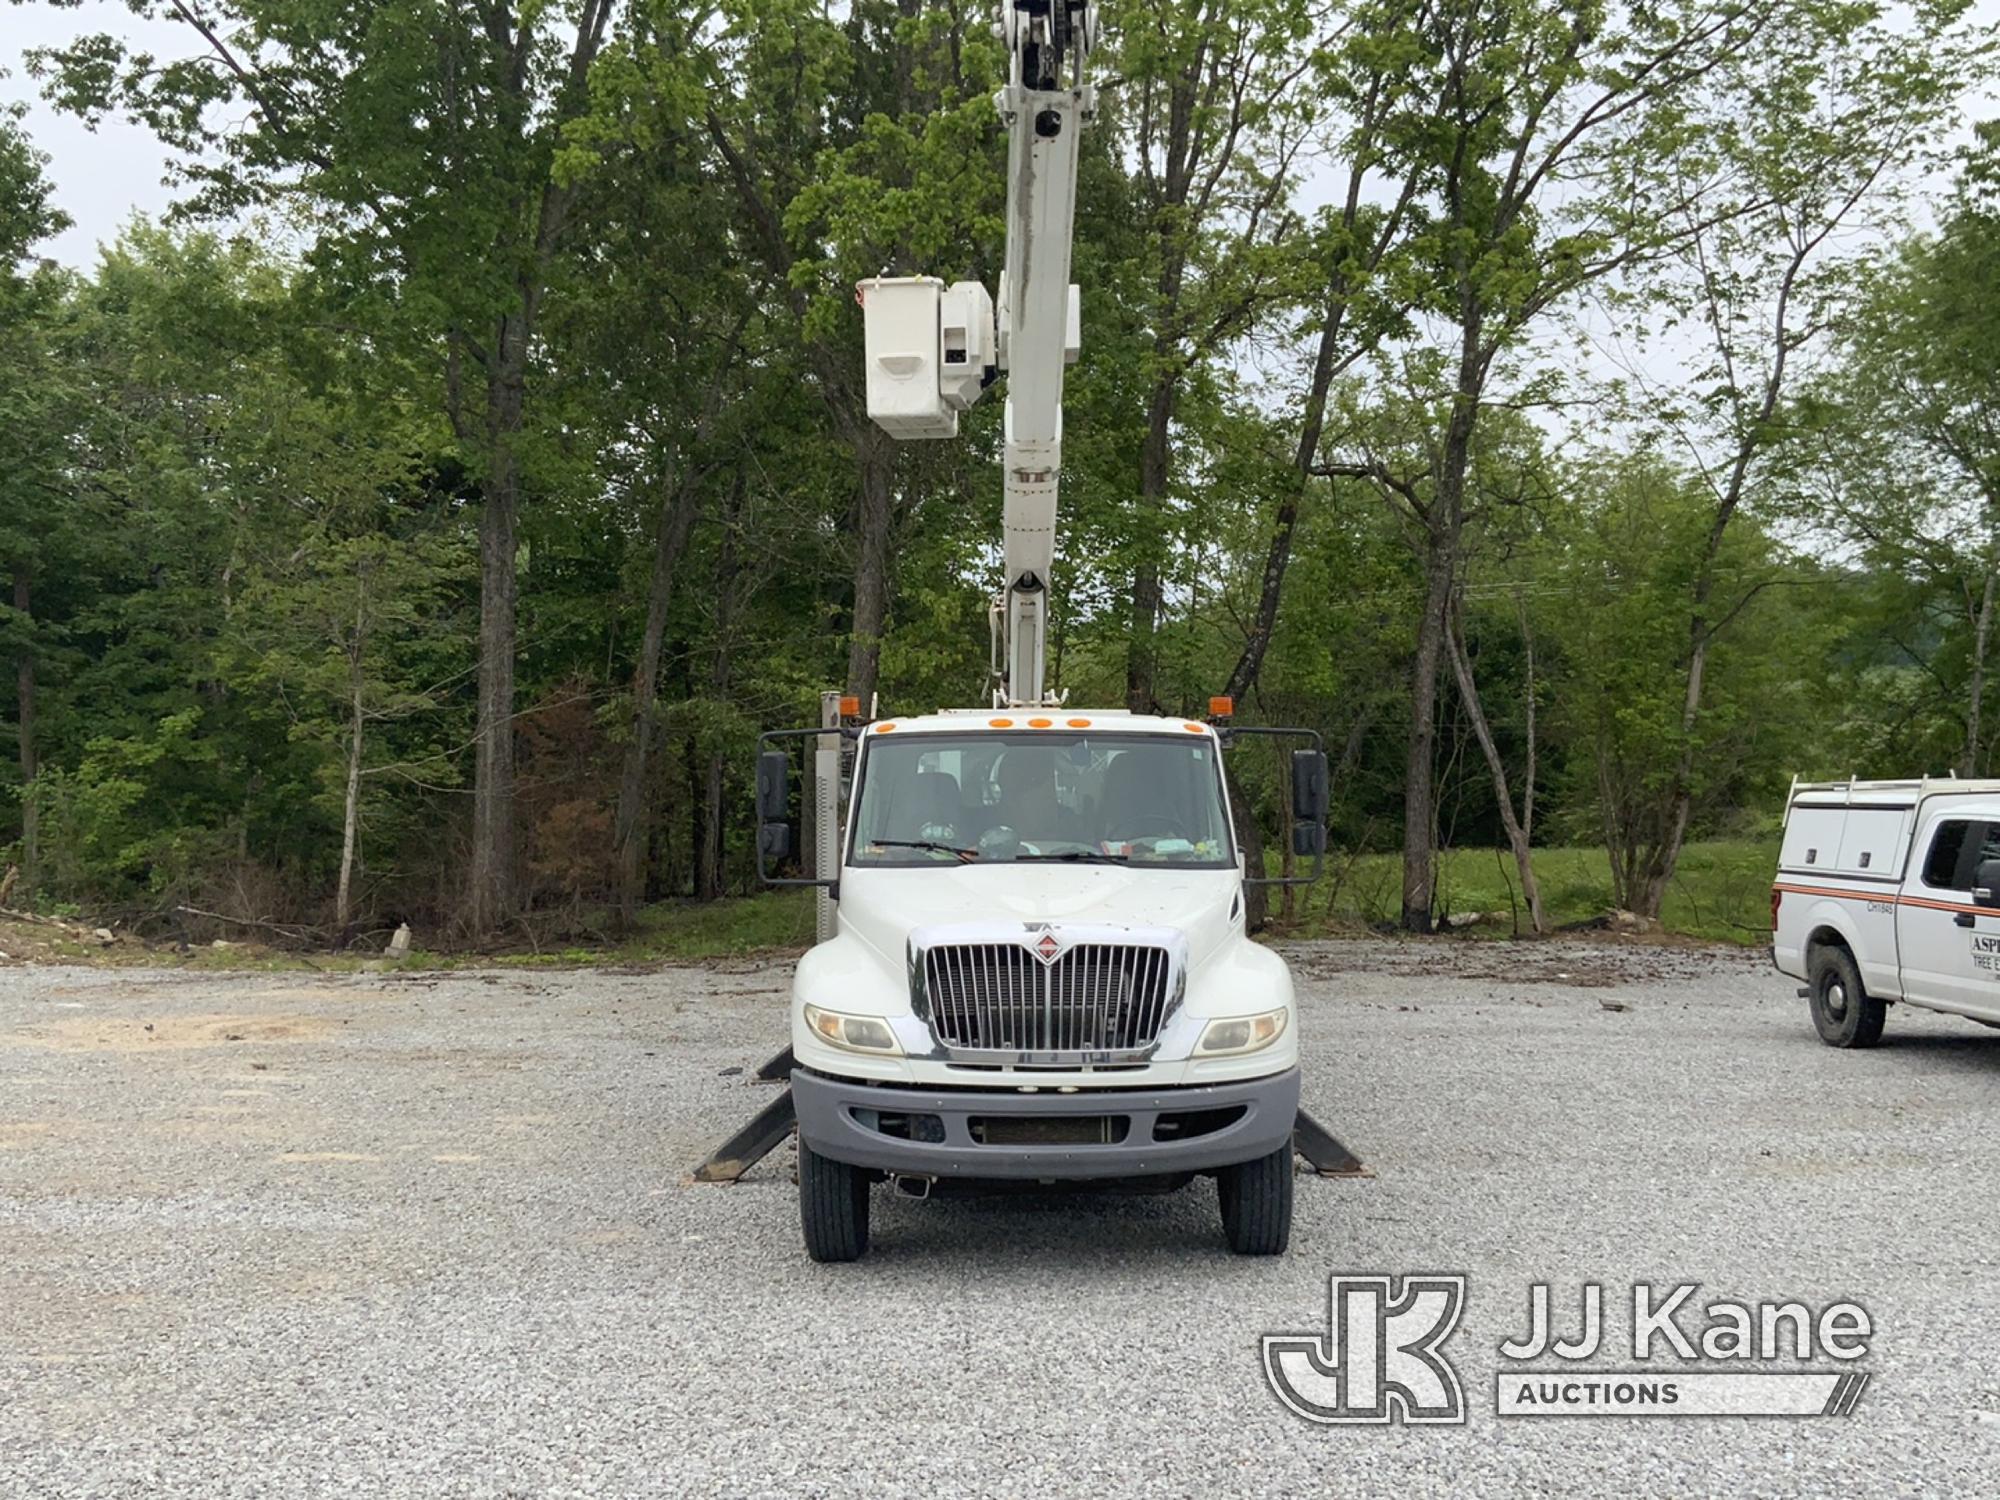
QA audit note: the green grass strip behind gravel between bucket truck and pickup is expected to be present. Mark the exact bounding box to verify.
[1272,838,1778,944]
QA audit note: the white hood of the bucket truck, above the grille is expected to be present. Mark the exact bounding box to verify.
[840,864,1242,974]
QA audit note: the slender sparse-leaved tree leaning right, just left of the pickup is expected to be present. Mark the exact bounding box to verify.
[1624,4,1990,918]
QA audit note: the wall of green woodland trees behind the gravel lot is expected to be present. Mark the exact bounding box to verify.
[0,0,2000,936]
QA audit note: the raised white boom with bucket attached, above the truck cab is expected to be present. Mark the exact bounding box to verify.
[858,0,1098,706]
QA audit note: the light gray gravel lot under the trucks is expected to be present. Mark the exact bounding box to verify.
[0,942,2000,1498]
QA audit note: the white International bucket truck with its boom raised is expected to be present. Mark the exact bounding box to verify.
[758,0,1326,1260]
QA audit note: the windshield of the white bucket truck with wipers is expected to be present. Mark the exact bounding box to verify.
[848,730,1236,870]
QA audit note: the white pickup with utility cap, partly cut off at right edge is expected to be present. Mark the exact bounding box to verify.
[1770,778,2000,1046]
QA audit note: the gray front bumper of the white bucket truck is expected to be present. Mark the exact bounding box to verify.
[792,1068,1298,1182]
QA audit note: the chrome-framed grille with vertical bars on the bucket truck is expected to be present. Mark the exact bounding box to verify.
[924,942,1170,1054]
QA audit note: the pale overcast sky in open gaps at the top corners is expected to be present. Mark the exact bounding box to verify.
[11,0,2000,266]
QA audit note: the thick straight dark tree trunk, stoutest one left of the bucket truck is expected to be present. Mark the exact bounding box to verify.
[468,328,528,938]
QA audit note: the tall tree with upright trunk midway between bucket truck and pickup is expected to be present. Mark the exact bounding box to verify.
[1304,0,1976,930]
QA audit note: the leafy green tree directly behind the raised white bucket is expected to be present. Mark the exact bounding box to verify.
[688,0,1004,702]
